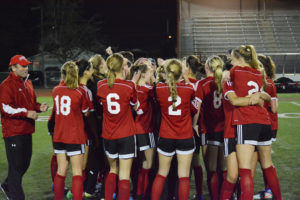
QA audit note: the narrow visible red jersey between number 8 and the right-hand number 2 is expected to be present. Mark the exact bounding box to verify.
[222,81,236,138]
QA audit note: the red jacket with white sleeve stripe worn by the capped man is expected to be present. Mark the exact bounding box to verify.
[0,72,41,138]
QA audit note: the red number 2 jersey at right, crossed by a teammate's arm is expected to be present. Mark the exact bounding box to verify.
[230,66,270,125]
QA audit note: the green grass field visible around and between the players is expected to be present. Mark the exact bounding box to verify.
[0,94,300,200]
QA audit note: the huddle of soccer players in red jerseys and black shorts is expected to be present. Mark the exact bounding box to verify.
[48,45,282,200]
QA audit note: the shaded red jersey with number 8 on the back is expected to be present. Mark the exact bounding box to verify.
[199,77,224,133]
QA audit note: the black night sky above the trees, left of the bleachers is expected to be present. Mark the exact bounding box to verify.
[0,0,177,71]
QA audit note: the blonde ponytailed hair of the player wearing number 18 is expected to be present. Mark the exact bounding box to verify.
[61,61,78,89]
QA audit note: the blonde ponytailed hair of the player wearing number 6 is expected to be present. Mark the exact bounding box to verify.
[106,53,124,89]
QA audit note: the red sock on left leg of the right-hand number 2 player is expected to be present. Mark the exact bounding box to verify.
[239,168,254,200]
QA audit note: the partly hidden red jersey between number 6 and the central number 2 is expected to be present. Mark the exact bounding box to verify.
[135,85,153,134]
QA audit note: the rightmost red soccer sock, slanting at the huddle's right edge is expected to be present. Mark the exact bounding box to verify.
[263,166,282,200]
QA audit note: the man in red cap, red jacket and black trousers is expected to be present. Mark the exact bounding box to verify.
[0,55,48,200]
